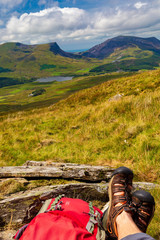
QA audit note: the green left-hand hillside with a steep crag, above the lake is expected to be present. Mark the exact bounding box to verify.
[0,43,101,87]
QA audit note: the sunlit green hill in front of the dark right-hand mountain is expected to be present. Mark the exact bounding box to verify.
[90,47,160,73]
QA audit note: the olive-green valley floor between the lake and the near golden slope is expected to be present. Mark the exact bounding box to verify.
[0,73,133,115]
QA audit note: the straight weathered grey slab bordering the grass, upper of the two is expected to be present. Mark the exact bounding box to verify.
[0,161,114,182]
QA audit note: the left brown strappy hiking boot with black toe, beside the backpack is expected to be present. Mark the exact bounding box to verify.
[105,167,133,238]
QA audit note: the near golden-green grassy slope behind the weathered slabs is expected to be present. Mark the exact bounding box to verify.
[0,70,160,240]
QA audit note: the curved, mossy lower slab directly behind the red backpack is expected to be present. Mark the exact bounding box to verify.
[0,183,108,230]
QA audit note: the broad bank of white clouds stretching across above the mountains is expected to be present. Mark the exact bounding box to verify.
[0,0,160,48]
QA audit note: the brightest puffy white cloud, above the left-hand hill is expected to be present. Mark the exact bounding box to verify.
[6,7,87,38]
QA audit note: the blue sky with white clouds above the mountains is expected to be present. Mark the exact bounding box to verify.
[0,0,160,51]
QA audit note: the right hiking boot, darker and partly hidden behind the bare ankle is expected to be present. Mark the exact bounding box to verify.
[131,190,155,233]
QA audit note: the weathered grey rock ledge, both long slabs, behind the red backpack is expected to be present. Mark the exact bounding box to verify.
[0,161,159,234]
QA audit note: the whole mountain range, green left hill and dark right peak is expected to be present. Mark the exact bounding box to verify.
[0,36,160,87]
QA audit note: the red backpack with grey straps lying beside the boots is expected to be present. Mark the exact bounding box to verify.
[14,195,102,240]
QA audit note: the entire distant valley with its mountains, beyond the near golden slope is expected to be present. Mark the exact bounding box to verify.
[0,36,160,115]
